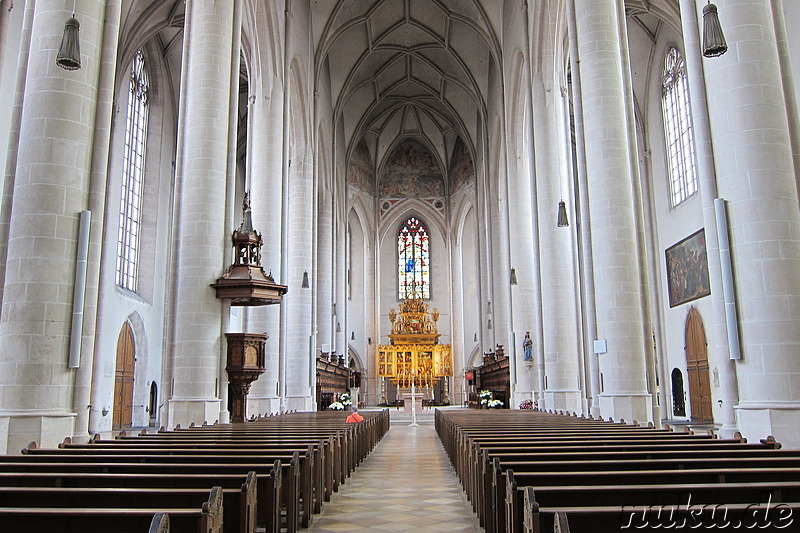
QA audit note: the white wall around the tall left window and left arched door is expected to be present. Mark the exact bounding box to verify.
[89,44,178,433]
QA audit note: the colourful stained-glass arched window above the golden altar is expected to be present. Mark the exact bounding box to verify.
[397,217,431,300]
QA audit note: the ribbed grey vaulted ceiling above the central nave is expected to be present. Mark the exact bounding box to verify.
[313,0,500,179]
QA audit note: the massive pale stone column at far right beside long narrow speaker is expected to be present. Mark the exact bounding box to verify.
[704,0,800,447]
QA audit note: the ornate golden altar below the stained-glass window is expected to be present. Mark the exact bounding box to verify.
[377,299,453,393]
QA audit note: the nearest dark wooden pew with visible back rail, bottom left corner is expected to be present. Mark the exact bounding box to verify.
[0,487,224,533]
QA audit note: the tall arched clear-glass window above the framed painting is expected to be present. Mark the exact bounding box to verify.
[661,47,697,207]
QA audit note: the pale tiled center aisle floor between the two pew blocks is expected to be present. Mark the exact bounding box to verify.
[305,412,483,533]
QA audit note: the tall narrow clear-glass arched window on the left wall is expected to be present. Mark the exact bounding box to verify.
[117,50,148,291]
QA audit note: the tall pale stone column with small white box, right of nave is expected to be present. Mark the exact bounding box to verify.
[573,0,652,422]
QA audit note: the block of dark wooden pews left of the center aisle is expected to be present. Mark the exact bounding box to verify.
[0,410,389,533]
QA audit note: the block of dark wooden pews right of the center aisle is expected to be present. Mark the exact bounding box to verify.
[435,410,800,533]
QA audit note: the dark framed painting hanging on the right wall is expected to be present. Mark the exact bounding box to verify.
[665,229,711,307]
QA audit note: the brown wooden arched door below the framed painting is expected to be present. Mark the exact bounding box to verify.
[686,308,714,423]
